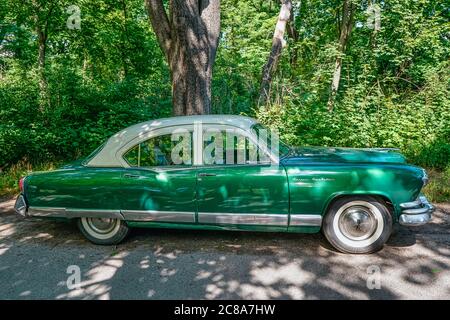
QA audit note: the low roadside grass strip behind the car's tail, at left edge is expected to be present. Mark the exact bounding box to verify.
[0,161,60,197]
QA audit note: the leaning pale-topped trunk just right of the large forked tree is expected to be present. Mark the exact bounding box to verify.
[259,0,292,105]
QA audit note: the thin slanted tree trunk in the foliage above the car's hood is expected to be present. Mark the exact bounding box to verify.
[327,0,355,112]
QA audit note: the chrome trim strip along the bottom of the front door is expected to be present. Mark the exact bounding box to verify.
[198,212,288,227]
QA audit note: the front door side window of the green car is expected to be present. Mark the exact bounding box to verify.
[203,129,270,165]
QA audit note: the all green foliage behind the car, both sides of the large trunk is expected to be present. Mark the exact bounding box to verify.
[0,0,450,195]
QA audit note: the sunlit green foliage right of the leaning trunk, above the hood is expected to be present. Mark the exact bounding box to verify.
[256,0,450,170]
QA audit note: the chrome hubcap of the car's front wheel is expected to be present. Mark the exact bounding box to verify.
[339,206,377,240]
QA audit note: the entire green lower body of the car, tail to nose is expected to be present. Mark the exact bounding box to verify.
[15,115,425,233]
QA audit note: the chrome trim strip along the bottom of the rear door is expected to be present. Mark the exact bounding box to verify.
[122,210,195,223]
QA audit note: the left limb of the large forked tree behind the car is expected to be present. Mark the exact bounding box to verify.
[145,0,172,61]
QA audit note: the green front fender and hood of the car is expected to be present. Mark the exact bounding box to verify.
[283,147,423,219]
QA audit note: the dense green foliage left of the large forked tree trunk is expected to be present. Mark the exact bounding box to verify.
[0,0,171,168]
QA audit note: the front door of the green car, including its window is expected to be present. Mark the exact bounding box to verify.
[197,125,289,230]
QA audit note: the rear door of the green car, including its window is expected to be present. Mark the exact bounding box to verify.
[121,126,196,223]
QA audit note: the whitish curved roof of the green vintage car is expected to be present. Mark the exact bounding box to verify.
[86,115,258,167]
